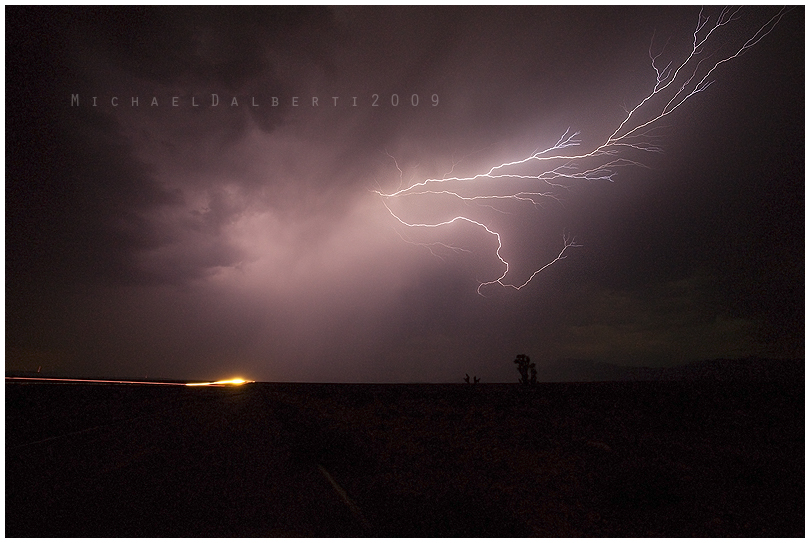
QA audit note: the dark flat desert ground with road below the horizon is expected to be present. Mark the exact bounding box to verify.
[5,382,804,537]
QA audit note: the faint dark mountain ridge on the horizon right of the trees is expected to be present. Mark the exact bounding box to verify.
[537,357,804,382]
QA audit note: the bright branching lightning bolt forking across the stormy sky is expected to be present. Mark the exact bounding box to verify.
[373,7,788,295]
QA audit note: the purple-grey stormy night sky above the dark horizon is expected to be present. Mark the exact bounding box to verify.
[5,6,805,382]
